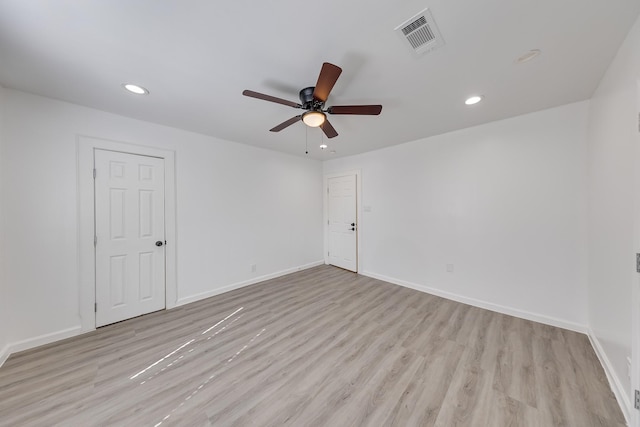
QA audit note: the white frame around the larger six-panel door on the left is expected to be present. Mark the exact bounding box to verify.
[76,135,178,332]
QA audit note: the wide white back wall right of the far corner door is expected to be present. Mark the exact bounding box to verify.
[324,100,588,330]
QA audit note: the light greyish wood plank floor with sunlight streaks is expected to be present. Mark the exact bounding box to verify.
[0,266,624,427]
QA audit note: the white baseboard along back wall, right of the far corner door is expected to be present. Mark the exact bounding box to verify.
[360,271,587,334]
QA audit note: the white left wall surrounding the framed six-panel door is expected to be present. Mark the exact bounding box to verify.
[0,90,322,348]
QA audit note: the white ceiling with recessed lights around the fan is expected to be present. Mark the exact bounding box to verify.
[0,0,640,159]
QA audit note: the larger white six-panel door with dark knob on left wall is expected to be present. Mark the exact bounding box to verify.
[94,149,165,326]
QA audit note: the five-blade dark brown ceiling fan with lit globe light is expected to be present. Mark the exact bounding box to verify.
[242,62,382,138]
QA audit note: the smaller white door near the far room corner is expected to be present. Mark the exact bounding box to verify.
[327,174,358,272]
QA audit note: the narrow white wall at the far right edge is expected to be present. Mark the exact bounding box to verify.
[588,14,640,418]
